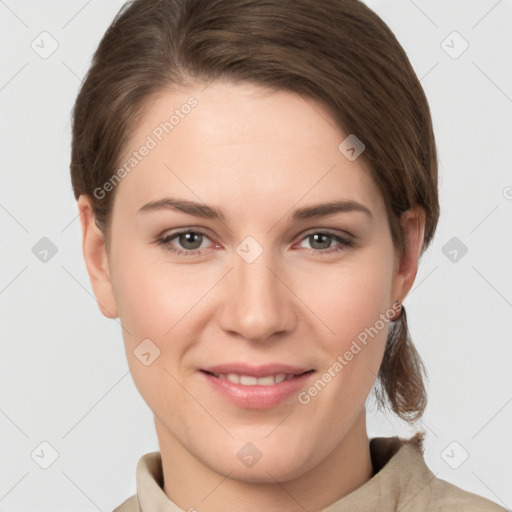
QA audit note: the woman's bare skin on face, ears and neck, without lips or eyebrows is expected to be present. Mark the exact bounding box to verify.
[78,82,425,512]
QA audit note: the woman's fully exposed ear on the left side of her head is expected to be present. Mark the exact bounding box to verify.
[78,194,118,318]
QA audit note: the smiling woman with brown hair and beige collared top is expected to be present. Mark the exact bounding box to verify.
[71,0,504,512]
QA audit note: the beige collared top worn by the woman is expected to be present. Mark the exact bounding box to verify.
[114,433,506,512]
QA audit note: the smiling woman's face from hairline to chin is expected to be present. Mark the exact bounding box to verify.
[82,82,423,482]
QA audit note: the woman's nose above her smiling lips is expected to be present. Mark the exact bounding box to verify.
[219,246,297,342]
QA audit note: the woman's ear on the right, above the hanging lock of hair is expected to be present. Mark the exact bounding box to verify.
[391,206,425,308]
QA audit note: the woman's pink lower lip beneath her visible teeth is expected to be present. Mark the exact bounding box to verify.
[200,371,314,409]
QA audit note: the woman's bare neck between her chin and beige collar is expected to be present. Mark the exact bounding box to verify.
[155,408,373,512]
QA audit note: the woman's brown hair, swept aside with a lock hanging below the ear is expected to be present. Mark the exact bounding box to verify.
[71,0,439,422]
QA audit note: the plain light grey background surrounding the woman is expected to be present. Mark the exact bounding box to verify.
[0,0,512,512]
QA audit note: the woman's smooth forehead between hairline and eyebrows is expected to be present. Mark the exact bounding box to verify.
[112,81,383,221]
